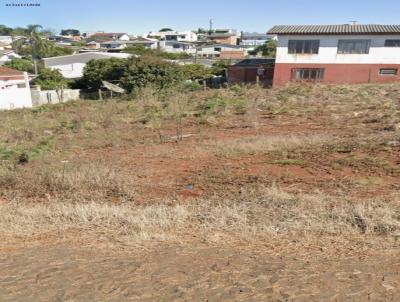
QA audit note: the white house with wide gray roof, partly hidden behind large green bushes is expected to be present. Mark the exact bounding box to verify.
[43,52,132,79]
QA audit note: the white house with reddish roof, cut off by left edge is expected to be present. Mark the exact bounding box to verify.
[0,66,32,109]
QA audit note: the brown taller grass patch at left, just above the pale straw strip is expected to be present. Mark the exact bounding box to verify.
[0,162,135,202]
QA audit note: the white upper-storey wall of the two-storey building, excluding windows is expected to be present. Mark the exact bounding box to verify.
[276,35,400,64]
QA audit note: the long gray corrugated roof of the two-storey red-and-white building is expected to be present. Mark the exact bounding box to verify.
[267,24,400,35]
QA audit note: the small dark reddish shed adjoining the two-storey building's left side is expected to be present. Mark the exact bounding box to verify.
[228,58,275,86]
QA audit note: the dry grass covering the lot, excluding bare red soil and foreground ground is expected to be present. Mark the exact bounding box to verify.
[0,85,400,248]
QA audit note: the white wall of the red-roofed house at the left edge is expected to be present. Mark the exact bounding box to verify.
[0,73,32,109]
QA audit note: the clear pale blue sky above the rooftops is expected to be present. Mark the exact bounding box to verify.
[0,0,400,34]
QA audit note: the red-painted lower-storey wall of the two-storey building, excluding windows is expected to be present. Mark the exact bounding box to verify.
[273,63,400,87]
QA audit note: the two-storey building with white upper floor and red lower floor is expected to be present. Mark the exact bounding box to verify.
[268,24,400,86]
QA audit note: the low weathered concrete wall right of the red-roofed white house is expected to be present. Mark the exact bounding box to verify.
[31,88,80,107]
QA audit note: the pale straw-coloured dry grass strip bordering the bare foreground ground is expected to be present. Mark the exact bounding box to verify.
[0,187,400,240]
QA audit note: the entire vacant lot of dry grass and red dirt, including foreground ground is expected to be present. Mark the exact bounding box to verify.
[0,85,400,301]
